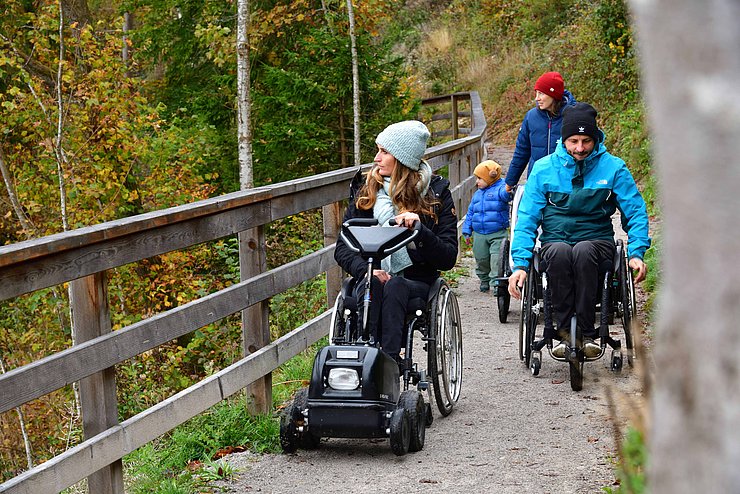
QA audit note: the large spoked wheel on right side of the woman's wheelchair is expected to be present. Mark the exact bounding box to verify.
[427,282,463,417]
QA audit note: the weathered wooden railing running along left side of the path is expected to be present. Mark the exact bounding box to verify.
[0,92,486,494]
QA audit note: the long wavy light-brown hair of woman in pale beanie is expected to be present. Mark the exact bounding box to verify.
[355,160,439,222]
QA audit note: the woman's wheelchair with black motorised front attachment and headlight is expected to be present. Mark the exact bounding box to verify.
[280,218,463,456]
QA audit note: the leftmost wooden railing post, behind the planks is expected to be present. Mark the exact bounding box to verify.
[70,271,124,494]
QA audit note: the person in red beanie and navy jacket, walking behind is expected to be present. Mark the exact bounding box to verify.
[505,72,576,192]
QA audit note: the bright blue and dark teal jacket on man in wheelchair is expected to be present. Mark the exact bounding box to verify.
[511,131,650,270]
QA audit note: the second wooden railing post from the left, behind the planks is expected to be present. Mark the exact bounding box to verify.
[239,226,272,415]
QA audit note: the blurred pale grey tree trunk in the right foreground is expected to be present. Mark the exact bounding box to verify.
[632,0,740,494]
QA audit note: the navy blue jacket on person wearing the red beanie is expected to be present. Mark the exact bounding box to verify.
[506,90,576,187]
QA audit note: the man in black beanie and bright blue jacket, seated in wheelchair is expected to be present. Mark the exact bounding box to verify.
[509,103,650,357]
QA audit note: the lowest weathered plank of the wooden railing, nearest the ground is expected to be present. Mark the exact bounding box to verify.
[0,311,330,494]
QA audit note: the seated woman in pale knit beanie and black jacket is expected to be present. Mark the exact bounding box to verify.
[334,120,458,365]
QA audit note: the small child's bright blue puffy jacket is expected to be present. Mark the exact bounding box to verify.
[463,178,512,236]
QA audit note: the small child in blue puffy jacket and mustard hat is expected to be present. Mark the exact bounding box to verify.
[462,160,513,292]
